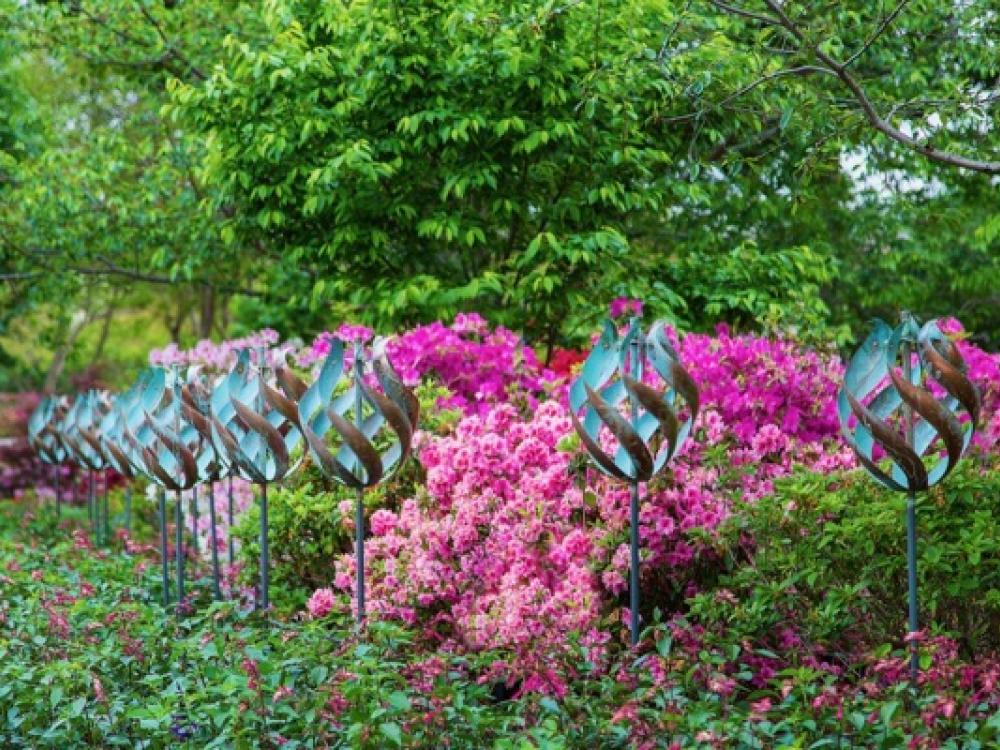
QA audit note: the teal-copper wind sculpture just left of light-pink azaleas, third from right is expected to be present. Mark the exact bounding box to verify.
[298,339,420,625]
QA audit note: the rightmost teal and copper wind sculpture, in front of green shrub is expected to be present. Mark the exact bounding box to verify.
[837,312,980,684]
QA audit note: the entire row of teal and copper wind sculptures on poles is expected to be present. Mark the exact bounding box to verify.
[30,314,979,668]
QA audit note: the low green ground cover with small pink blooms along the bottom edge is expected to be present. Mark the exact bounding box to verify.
[0,505,1000,750]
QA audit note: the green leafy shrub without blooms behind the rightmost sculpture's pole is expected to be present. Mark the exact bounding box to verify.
[690,460,1000,653]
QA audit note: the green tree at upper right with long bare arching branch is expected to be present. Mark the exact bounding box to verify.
[677,0,1000,345]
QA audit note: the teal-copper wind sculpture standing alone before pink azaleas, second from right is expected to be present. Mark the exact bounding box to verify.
[569,317,698,646]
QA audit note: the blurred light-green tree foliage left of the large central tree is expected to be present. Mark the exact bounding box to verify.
[0,0,266,388]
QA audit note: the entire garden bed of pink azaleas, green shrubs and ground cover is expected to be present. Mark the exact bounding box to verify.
[0,314,1000,748]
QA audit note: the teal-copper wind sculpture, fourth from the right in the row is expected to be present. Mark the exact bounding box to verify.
[210,350,302,612]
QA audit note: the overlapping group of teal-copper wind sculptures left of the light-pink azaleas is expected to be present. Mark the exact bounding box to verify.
[29,340,419,622]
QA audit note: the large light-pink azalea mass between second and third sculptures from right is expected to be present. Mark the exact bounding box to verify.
[335,401,601,676]
